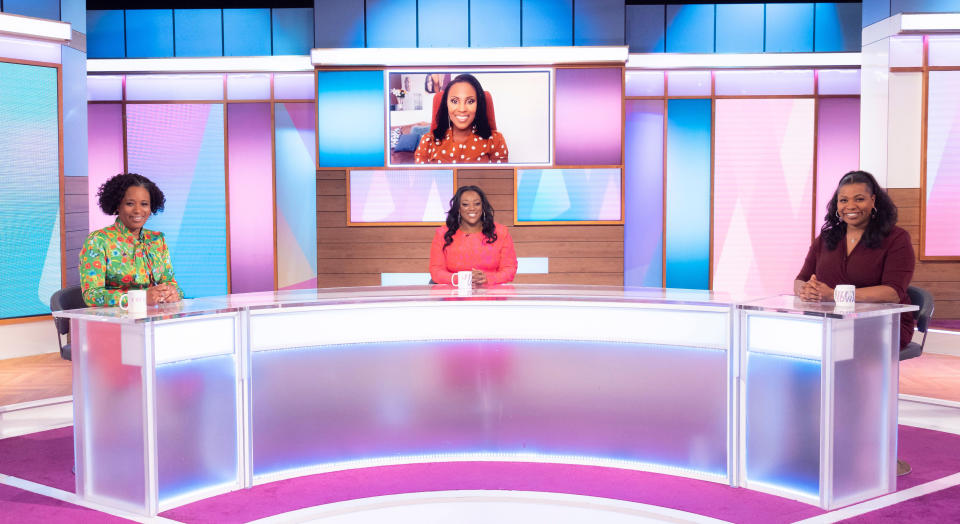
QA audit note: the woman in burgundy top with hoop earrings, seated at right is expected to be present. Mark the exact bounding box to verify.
[793,171,916,348]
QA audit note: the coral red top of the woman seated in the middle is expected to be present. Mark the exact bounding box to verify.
[430,223,517,284]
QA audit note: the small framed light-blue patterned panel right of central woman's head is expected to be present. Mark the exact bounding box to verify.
[516,168,622,222]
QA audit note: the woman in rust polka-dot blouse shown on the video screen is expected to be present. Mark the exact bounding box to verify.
[413,74,507,164]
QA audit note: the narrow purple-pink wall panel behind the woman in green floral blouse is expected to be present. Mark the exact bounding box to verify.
[87,104,123,231]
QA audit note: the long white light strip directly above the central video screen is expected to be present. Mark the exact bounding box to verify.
[310,46,629,66]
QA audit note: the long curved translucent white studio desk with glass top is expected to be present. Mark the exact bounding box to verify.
[59,285,915,515]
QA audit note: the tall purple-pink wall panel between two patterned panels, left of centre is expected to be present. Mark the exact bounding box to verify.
[227,103,274,293]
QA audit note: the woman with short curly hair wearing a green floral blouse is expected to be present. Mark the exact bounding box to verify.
[79,173,183,306]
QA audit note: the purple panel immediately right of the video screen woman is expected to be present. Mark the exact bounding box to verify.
[555,67,623,166]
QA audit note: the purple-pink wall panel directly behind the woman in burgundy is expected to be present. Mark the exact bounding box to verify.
[813,98,860,232]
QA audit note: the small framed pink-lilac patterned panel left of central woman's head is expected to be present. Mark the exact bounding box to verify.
[349,169,453,223]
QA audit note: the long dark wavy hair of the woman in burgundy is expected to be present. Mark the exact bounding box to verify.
[820,171,897,251]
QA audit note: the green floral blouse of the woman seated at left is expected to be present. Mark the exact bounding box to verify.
[79,220,183,306]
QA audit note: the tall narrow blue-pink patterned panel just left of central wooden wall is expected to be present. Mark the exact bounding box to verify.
[274,102,317,289]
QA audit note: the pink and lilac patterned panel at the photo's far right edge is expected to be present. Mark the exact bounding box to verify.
[923,71,960,257]
